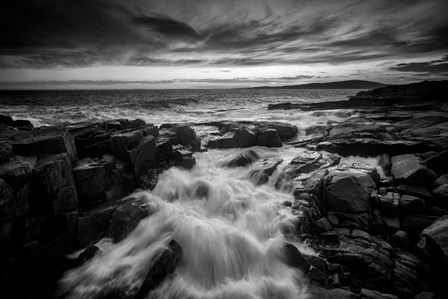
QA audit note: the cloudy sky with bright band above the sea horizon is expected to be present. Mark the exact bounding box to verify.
[0,0,448,89]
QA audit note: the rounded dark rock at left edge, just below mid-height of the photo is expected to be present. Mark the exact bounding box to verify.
[0,156,37,186]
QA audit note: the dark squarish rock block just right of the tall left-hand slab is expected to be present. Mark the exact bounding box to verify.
[73,158,106,206]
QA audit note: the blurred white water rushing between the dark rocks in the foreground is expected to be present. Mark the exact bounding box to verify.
[61,148,312,299]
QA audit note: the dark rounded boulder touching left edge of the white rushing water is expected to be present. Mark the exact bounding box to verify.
[106,200,149,243]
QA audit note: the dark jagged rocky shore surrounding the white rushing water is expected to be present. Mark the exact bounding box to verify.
[0,82,448,299]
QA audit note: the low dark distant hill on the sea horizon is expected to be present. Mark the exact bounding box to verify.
[253,80,387,89]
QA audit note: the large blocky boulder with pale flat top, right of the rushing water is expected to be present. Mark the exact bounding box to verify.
[325,169,376,213]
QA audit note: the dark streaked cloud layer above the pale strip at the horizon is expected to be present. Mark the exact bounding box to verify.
[0,0,448,72]
